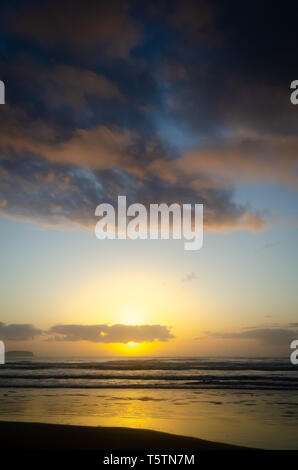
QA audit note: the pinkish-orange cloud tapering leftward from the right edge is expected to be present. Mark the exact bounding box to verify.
[172,137,298,191]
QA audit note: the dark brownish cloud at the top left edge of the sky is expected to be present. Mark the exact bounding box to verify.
[2,0,140,57]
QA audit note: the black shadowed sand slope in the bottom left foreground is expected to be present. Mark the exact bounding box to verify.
[0,421,244,451]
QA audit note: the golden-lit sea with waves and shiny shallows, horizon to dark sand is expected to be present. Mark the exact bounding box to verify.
[0,357,298,449]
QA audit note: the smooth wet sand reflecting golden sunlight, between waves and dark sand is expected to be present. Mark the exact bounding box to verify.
[0,389,298,449]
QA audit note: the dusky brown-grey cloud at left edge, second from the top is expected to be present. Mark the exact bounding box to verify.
[4,62,121,112]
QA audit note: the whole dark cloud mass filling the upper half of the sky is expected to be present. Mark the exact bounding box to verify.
[0,0,298,230]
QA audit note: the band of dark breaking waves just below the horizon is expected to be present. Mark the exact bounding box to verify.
[0,358,298,390]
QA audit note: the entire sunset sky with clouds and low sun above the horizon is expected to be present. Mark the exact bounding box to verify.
[0,0,298,356]
